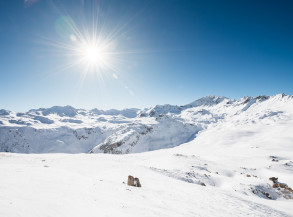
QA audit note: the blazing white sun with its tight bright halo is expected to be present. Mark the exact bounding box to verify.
[53,16,122,81]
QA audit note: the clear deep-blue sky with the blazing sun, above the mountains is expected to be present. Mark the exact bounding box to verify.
[0,0,293,111]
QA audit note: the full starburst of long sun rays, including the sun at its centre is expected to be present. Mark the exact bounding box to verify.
[32,2,150,101]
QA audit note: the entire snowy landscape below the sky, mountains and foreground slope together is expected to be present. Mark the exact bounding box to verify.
[0,94,293,217]
